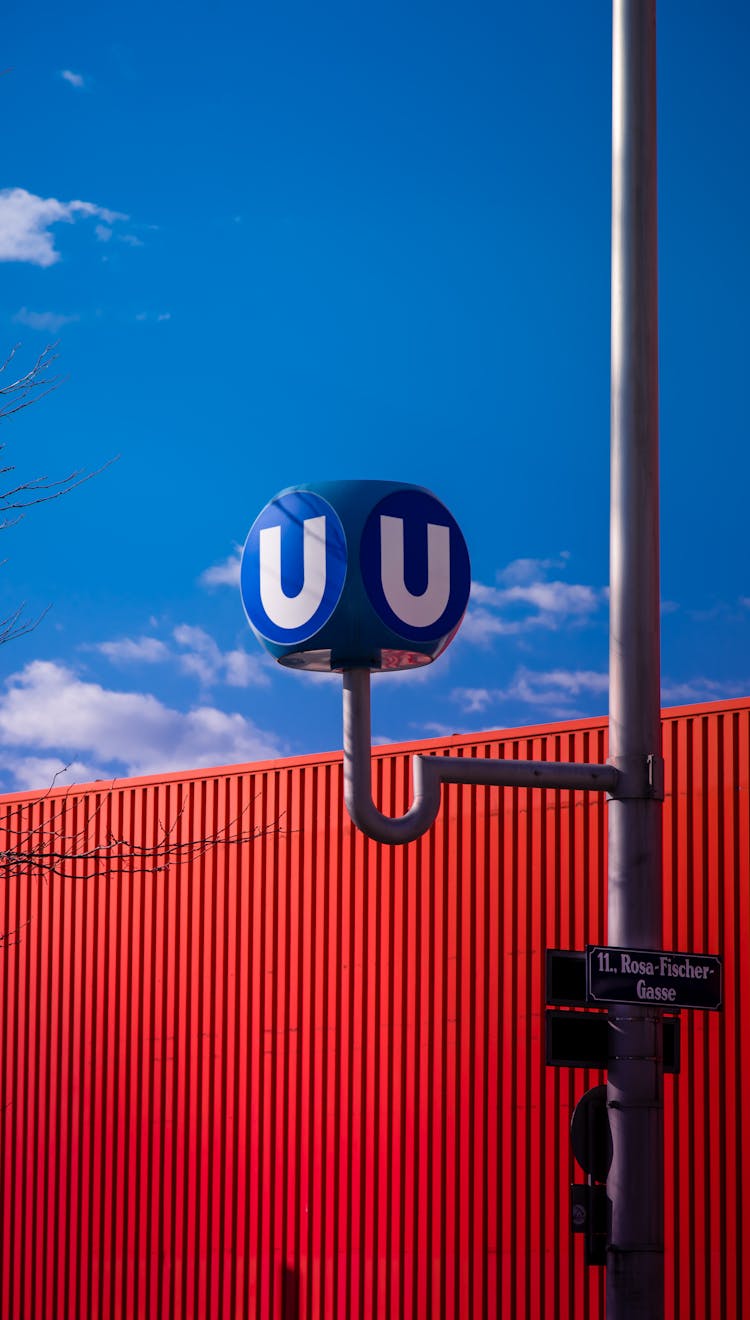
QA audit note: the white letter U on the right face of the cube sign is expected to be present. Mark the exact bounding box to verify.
[380,513,450,628]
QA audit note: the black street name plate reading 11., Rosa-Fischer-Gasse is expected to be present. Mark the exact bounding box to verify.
[586,944,722,1010]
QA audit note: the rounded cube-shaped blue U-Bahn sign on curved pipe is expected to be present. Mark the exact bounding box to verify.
[240,480,470,671]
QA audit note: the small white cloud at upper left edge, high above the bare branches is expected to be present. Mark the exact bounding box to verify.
[0,187,128,267]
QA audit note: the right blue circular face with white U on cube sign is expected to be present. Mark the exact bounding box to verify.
[359,488,471,642]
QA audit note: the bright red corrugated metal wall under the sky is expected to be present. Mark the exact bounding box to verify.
[0,701,750,1320]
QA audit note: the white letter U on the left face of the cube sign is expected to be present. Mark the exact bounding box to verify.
[259,513,326,630]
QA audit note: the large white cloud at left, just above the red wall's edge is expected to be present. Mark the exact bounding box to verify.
[0,660,285,787]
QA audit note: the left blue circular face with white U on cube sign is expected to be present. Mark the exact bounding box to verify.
[240,490,346,645]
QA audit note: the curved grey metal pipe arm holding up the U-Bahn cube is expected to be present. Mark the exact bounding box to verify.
[343,669,622,843]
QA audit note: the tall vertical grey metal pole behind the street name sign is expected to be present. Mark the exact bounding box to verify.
[607,0,664,1320]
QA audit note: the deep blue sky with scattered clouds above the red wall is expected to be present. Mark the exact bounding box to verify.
[0,0,750,788]
